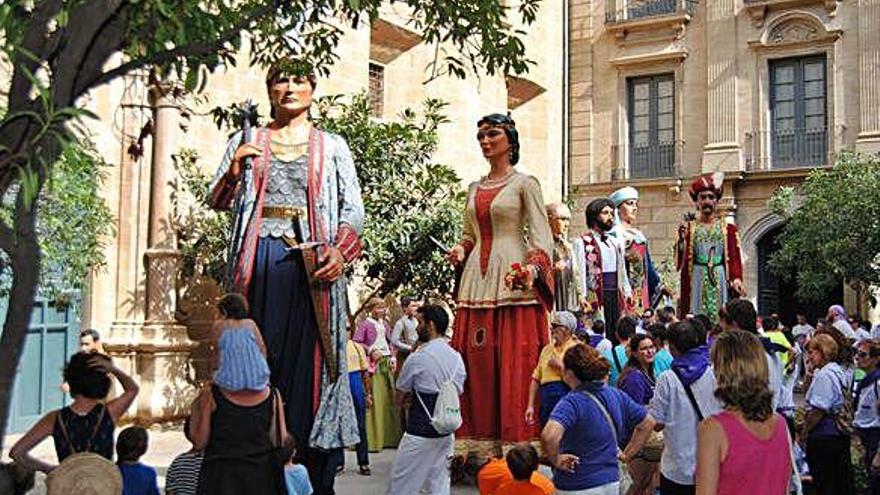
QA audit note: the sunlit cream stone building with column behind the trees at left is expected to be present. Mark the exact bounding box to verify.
[62,2,565,423]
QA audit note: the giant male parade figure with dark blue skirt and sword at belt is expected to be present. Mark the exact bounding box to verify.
[211,67,364,494]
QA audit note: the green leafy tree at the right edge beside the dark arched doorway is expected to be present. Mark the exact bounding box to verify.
[770,152,880,301]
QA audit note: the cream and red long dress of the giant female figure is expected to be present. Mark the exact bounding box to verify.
[452,171,553,454]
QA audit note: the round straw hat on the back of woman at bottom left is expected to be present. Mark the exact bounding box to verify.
[46,452,122,495]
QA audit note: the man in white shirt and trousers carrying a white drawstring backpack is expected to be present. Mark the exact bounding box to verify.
[388,305,467,495]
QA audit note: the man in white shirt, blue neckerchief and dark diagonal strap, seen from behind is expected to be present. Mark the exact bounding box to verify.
[649,320,721,495]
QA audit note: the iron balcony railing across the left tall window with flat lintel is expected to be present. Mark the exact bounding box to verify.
[611,141,684,181]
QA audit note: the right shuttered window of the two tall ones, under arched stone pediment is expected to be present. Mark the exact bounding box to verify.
[770,55,828,168]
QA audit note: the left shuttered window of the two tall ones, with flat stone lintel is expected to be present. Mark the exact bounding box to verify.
[627,74,675,178]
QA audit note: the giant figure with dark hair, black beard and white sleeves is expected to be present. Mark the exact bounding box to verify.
[573,198,632,335]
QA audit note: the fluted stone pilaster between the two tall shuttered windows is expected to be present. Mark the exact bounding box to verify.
[701,0,741,172]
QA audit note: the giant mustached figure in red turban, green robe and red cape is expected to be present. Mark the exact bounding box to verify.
[675,172,746,323]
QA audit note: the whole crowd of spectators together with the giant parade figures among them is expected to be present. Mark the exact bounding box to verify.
[3,66,880,495]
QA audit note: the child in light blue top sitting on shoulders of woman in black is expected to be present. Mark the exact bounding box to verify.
[213,293,269,391]
